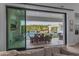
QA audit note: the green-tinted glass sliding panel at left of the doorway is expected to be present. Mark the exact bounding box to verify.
[6,8,26,49]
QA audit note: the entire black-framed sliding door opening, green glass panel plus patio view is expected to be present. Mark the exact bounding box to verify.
[6,7,67,50]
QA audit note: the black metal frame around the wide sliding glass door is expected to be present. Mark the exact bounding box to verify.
[6,5,67,50]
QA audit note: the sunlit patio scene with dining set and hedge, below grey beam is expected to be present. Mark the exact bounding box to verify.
[26,21,64,49]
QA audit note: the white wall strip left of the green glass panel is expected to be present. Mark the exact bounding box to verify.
[0,4,6,50]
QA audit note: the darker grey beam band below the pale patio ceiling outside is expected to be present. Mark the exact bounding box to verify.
[26,16,64,22]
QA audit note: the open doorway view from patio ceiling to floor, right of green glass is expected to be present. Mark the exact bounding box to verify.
[26,10,64,49]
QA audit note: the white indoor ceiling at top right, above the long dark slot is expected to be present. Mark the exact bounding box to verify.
[32,3,79,12]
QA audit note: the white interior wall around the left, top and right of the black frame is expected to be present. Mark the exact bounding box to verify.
[0,4,76,50]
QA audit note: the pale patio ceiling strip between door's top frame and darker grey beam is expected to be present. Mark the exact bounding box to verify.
[26,10,64,19]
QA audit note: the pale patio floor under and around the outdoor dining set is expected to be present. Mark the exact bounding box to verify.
[26,38,64,49]
